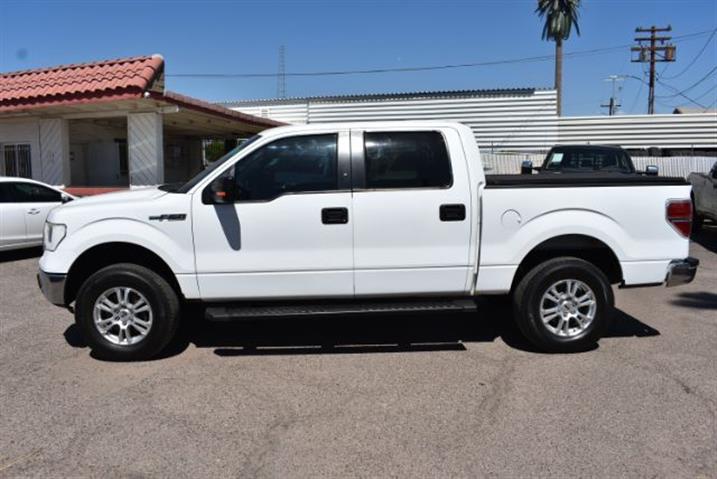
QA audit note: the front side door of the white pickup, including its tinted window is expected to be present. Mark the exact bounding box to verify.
[192,131,353,300]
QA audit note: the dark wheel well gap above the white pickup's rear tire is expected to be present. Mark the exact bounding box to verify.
[511,235,622,289]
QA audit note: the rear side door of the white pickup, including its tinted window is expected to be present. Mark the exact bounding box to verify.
[351,128,472,296]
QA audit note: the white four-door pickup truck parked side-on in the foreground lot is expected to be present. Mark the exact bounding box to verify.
[38,122,697,360]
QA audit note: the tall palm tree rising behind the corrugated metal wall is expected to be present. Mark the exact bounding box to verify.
[535,0,580,116]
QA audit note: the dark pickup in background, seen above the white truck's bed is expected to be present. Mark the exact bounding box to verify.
[521,145,658,176]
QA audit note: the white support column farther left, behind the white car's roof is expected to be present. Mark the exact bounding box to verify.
[38,118,71,186]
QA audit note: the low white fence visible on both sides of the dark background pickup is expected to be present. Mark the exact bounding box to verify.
[481,153,717,177]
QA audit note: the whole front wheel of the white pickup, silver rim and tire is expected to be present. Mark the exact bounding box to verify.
[75,263,179,361]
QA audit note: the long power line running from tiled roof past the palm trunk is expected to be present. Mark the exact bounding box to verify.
[166,30,712,79]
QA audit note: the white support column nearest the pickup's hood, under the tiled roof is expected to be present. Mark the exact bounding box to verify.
[127,113,164,186]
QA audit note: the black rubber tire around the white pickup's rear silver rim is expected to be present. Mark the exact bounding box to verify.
[513,257,615,353]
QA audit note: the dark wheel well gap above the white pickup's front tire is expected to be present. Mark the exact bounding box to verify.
[65,243,182,304]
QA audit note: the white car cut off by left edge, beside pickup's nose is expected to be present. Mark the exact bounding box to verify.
[0,176,75,251]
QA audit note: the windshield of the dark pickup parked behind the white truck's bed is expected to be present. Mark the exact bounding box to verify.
[543,149,634,173]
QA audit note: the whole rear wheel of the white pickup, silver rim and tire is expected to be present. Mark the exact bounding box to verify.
[513,257,614,352]
